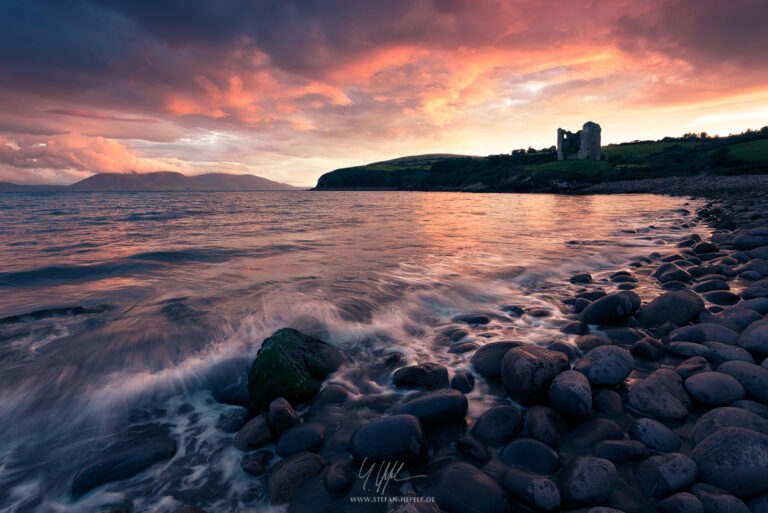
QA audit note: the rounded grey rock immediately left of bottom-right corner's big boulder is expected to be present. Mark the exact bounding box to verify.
[635,452,699,497]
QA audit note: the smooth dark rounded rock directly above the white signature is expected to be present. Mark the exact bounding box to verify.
[350,415,425,462]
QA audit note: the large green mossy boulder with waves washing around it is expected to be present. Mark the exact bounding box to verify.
[248,328,349,411]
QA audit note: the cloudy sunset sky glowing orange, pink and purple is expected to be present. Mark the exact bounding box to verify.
[0,0,768,185]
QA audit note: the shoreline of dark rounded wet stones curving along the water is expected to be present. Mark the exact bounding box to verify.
[73,182,768,513]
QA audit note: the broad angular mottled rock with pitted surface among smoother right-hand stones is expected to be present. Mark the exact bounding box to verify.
[627,369,690,419]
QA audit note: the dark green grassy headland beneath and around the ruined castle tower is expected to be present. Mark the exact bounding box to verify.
[317,126,768,192]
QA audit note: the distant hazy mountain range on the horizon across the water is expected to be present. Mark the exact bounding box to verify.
[0,171,302,192]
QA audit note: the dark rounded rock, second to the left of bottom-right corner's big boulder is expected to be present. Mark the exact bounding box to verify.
[558,456,618,506]
